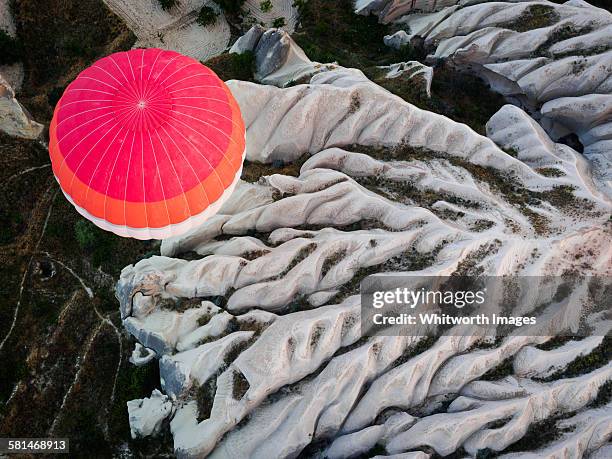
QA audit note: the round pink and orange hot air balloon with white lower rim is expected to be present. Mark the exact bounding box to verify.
[49,49,245,239]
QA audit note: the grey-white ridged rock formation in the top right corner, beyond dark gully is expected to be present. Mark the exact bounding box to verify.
[377,0,612,192]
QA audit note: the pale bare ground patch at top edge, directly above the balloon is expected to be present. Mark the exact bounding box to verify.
[104,0,230,60]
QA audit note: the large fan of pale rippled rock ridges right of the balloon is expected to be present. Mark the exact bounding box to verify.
[117,63,612,458]
